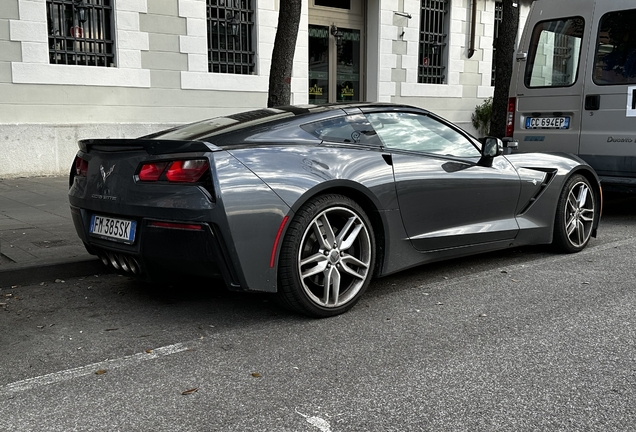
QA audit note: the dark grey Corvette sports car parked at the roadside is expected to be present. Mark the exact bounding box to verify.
[69,103,602,317]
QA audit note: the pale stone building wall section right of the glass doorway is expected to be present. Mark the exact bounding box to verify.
[386,0,531,133]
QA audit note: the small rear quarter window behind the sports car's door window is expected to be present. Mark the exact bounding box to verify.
[301,114,382,146]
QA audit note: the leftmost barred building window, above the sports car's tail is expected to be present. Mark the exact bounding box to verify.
[46,0,115,67]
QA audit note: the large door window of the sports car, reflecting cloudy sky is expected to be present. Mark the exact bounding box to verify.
[367,112,480,157]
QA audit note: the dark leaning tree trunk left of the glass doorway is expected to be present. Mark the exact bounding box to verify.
[267,0,302,108]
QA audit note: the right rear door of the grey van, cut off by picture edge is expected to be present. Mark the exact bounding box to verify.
[579,0,636,187]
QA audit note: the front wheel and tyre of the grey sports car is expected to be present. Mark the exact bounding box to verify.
[552,174,598,253]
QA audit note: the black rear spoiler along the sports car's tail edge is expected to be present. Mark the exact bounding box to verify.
[77,139,221,155]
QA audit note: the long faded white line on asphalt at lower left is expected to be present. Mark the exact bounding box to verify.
[0,343,188,393]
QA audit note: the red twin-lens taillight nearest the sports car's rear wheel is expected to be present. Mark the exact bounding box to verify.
[138,159,210,183]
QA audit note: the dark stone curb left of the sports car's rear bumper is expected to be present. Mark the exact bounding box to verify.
[0,257,108,288]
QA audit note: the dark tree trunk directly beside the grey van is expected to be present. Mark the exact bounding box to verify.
[490,0,519,138]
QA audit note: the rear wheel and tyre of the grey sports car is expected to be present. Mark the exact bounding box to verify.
[278,194,375,318]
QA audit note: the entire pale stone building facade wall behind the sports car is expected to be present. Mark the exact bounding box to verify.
[0,0,523,178]
